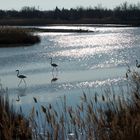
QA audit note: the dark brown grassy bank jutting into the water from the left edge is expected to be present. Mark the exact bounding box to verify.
[0,27,40,47]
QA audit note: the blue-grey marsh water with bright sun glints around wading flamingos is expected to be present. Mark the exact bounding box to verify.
[0,25,140,110]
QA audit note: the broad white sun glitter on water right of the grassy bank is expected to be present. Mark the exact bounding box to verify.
[47,30,132,58]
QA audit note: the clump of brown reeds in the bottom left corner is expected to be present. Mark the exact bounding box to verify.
[0,83,32,140]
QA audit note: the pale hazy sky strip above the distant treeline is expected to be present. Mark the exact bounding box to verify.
[0,0,140,10]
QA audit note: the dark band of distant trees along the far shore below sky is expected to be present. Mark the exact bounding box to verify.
[0,2,140,26]
